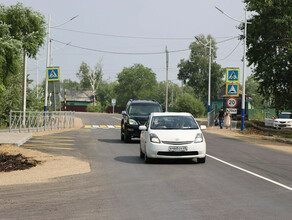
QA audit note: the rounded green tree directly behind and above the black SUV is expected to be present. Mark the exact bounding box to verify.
[115,64,157,106]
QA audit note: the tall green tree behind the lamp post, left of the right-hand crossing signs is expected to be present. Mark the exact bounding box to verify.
[178,35,224,101]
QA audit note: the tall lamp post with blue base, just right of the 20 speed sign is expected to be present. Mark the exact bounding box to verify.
[215,7,248,131]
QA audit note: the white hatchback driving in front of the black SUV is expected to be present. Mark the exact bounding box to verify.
[139,112,206,163]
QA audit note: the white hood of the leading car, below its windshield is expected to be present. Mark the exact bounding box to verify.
[151,129,202,141]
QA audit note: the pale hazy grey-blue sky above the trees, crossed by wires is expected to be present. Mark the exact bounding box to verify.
[0,0,251,87]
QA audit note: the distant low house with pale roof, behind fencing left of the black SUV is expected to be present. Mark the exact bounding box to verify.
[61,89,93,112]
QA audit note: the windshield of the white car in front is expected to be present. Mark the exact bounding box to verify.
[151,115,199,130]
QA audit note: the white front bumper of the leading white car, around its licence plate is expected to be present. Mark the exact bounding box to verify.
[146,142,206,159]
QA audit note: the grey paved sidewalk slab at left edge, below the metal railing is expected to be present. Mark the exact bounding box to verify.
[0,132,33,146]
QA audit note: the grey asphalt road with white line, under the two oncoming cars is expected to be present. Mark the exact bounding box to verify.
[0,114,292,220]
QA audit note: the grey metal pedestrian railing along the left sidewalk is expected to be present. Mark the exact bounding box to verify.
[9,111,75,132]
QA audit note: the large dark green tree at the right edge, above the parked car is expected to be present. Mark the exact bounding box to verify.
[240,0,292,110]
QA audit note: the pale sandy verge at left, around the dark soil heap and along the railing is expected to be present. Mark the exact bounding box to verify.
[0,118,91,186]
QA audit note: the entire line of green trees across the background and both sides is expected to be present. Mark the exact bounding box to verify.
[0,0,292,127]
